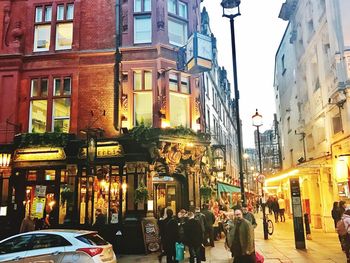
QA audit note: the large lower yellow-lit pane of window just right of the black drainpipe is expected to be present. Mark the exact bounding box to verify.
[134,92,153,126]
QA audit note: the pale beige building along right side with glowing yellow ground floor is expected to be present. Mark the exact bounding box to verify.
[266,0,350,232]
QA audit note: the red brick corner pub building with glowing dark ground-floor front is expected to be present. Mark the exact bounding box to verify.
[0,0,210,253]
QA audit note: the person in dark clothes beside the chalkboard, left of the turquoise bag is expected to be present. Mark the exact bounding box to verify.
[163,208,179,263]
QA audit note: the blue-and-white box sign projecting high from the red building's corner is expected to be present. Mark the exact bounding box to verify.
[186,32,213,74]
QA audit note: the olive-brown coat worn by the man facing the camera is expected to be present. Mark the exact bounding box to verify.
[227,218,255,255]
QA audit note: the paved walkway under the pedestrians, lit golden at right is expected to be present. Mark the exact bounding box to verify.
[118,214,346,263]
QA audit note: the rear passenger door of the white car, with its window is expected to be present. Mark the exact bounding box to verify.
[24,233,71,263]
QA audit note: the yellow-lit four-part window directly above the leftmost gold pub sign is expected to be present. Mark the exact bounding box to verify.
[29,77,71,133]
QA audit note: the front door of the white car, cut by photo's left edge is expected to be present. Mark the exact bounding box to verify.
[0,234,33,263]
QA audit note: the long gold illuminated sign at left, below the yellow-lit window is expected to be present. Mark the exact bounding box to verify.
[13,147,66,162]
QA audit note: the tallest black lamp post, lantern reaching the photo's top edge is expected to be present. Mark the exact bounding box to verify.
[221,0,246,204]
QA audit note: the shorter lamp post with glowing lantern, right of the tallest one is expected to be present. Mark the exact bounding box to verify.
[252,109,269,240]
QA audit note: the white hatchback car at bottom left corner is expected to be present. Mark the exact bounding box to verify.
[0,229,117,263]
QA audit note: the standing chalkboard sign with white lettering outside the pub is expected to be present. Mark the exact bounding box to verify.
[141,218,160,254]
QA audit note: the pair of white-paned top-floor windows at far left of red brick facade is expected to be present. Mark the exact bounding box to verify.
[33,3,74,52]
